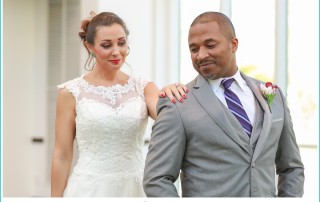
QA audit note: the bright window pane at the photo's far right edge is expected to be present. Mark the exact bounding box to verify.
[288,0,319,146]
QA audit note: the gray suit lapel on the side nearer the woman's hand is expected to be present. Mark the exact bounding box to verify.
[193,75,247,151]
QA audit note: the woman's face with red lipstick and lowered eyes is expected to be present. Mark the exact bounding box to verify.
[91,23,129,70]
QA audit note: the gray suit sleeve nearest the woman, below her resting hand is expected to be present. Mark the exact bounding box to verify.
[143,99,186,197]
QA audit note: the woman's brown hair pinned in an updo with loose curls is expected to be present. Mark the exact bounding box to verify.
[79,11,129,70]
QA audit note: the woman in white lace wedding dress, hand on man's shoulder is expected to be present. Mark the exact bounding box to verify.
[51,12,187,197]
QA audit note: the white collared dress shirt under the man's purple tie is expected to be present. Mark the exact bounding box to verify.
[209,70,256,126]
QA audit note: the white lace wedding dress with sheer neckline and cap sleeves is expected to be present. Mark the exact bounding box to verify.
[58,76,148,197]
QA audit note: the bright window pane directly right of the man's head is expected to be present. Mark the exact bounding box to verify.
[231,0,275,82]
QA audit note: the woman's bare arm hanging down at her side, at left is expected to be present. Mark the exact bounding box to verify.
[51,89,76,197]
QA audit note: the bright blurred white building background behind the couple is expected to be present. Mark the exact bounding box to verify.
[1,0,319,201]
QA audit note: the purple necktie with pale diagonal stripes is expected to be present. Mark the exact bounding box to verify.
[221,78,252,137]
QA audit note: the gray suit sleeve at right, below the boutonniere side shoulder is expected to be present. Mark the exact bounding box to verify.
[276,89,304,197]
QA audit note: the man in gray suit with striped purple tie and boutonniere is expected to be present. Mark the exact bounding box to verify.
[143,12,304,197]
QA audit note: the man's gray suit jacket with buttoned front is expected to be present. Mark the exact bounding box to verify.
[143,74,304,197]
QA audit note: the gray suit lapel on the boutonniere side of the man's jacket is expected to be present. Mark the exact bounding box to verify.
[241,73,272,161]
